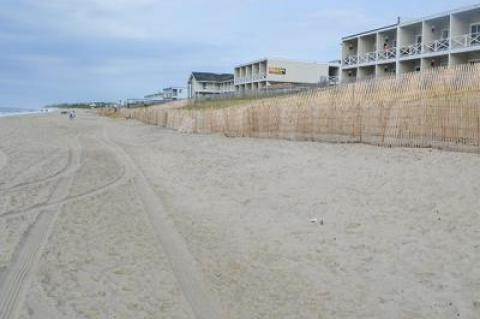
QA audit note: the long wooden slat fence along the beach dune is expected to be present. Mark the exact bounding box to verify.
[103,65,480,152]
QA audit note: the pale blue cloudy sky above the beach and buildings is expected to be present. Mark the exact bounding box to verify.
[0,0,478,108]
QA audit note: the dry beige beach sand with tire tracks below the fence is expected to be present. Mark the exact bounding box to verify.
[0,112,480,319]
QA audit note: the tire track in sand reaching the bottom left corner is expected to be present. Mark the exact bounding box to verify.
[0,138,81,319]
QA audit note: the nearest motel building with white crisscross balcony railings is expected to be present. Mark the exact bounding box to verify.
[342,5,480,82]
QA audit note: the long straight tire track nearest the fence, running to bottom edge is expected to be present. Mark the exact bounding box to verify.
[103,130,224,319]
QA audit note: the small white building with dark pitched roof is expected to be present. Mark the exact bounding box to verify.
[188,72,235,99]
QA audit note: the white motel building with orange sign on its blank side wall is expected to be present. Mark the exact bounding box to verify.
[235,58,340,93]
